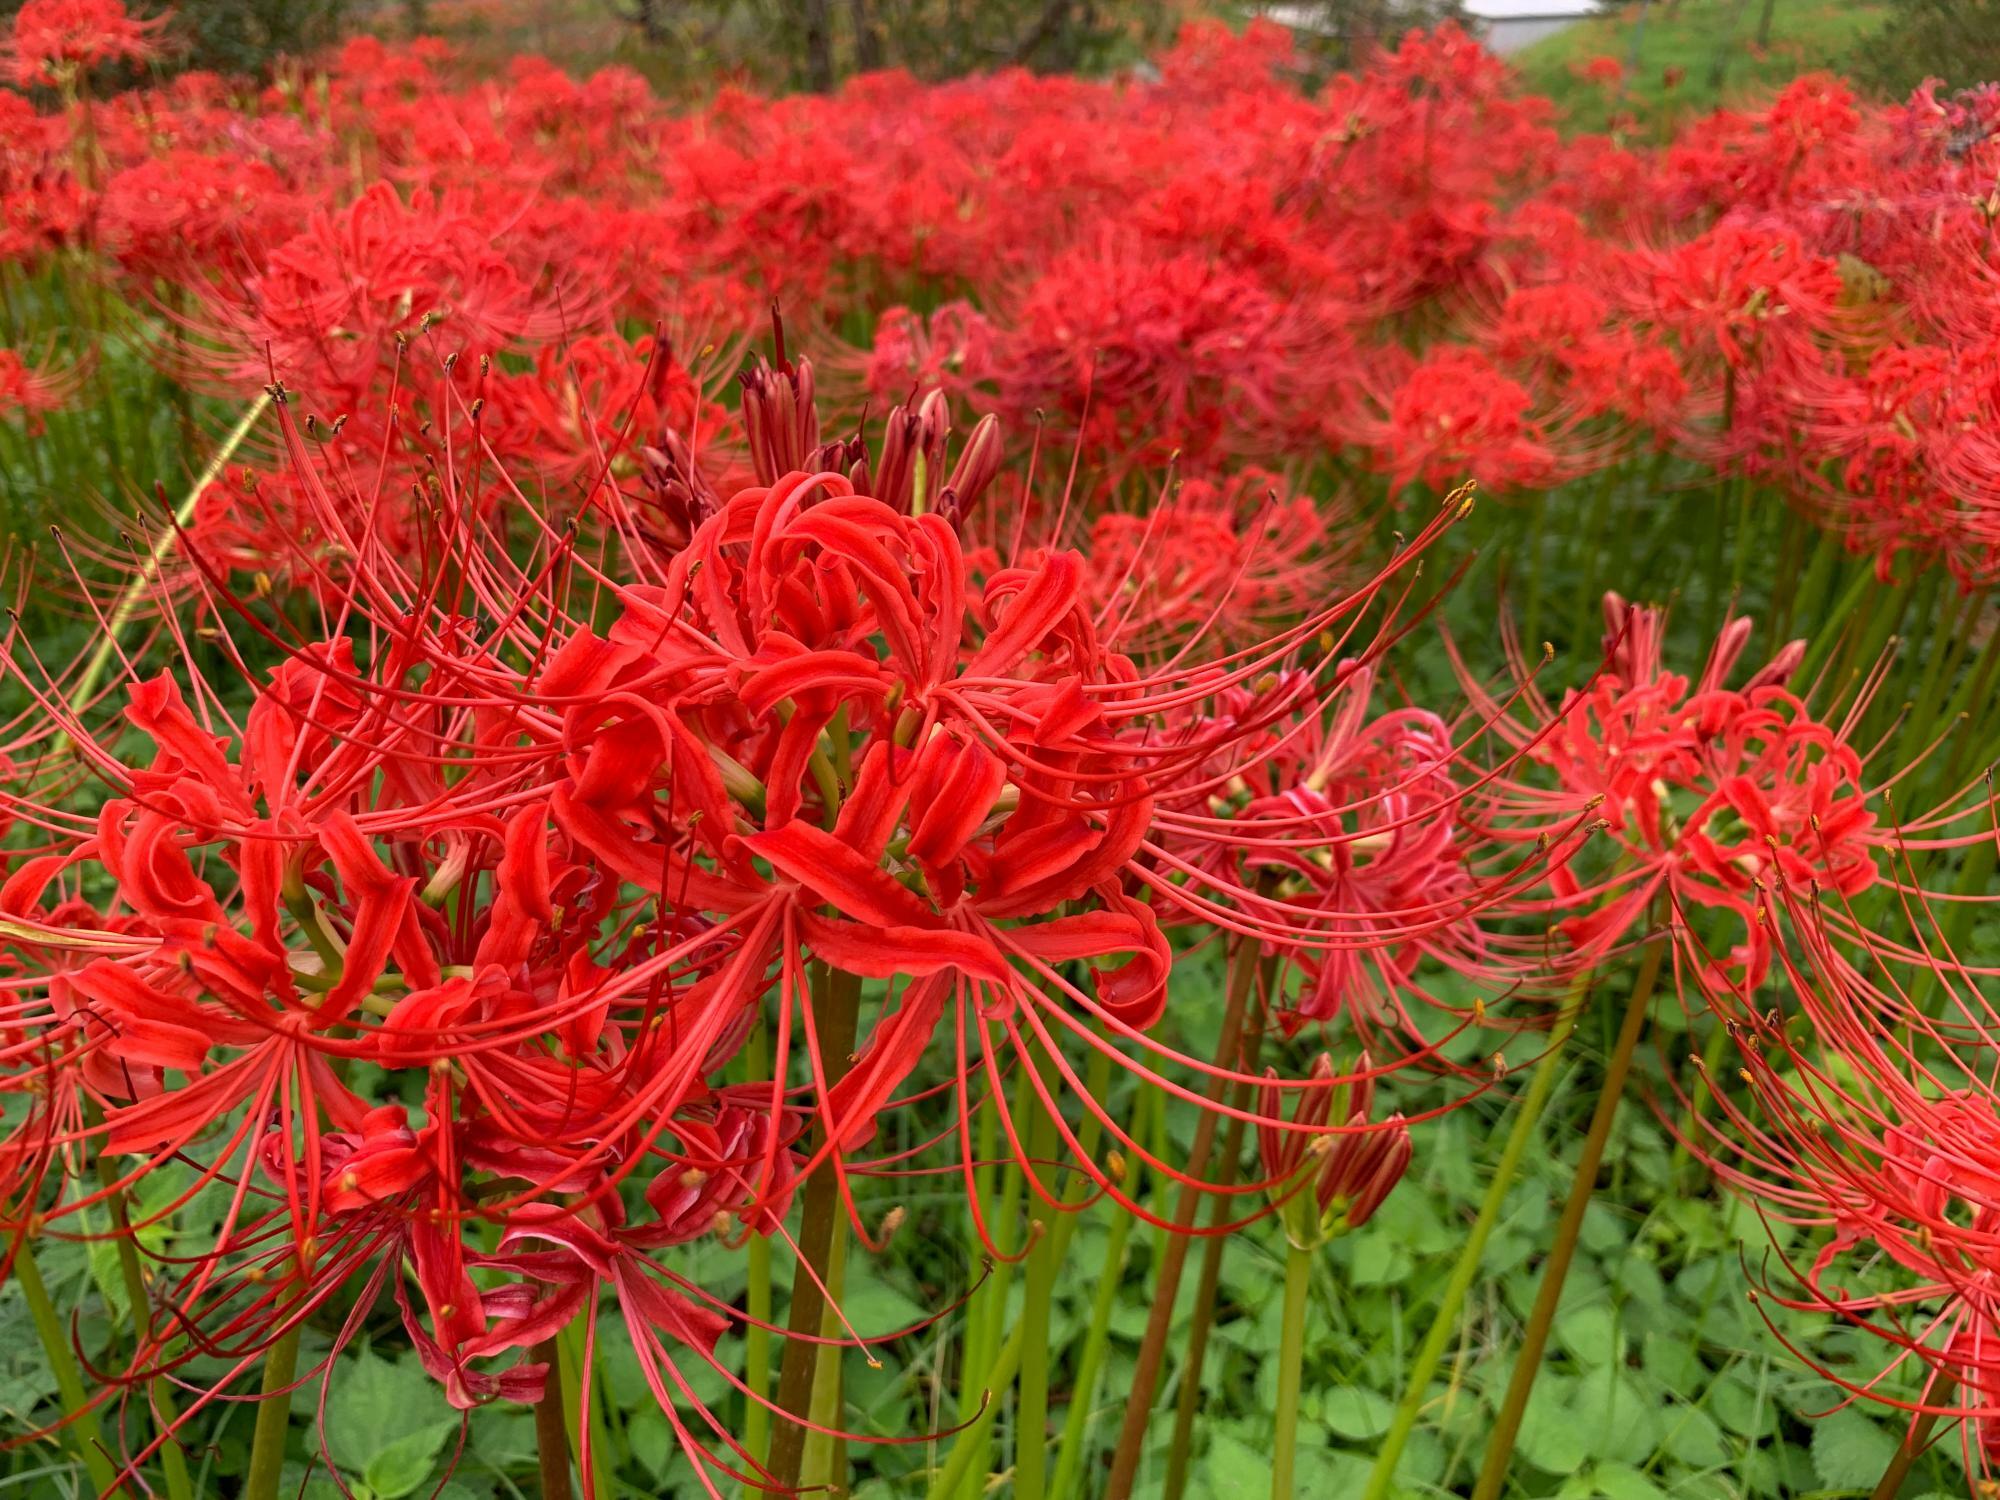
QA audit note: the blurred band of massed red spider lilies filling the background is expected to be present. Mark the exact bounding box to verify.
[0,20,2000,582]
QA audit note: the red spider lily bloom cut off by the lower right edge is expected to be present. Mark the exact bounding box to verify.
[1692,864,2000,1472]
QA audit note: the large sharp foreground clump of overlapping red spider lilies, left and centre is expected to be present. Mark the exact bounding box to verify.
[0,358,1586,1486]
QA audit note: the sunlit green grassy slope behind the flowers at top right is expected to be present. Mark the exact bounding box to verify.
[1514,0,1888,130]
